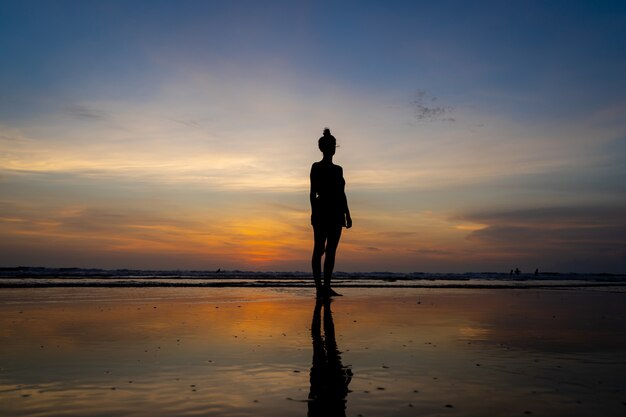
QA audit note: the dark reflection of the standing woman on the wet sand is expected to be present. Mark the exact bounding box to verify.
[308,298,352,417]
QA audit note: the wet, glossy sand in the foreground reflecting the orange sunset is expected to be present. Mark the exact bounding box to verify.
[0,288,626,416]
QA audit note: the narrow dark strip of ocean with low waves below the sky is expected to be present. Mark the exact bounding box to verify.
[0,267,626,290]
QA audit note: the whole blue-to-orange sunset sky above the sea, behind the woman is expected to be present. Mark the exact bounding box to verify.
[0,0,626,273]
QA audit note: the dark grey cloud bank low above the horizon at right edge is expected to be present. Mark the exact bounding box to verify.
[454,205,626,273]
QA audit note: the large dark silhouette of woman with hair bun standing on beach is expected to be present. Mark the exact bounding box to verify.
[310,128,352,297]
